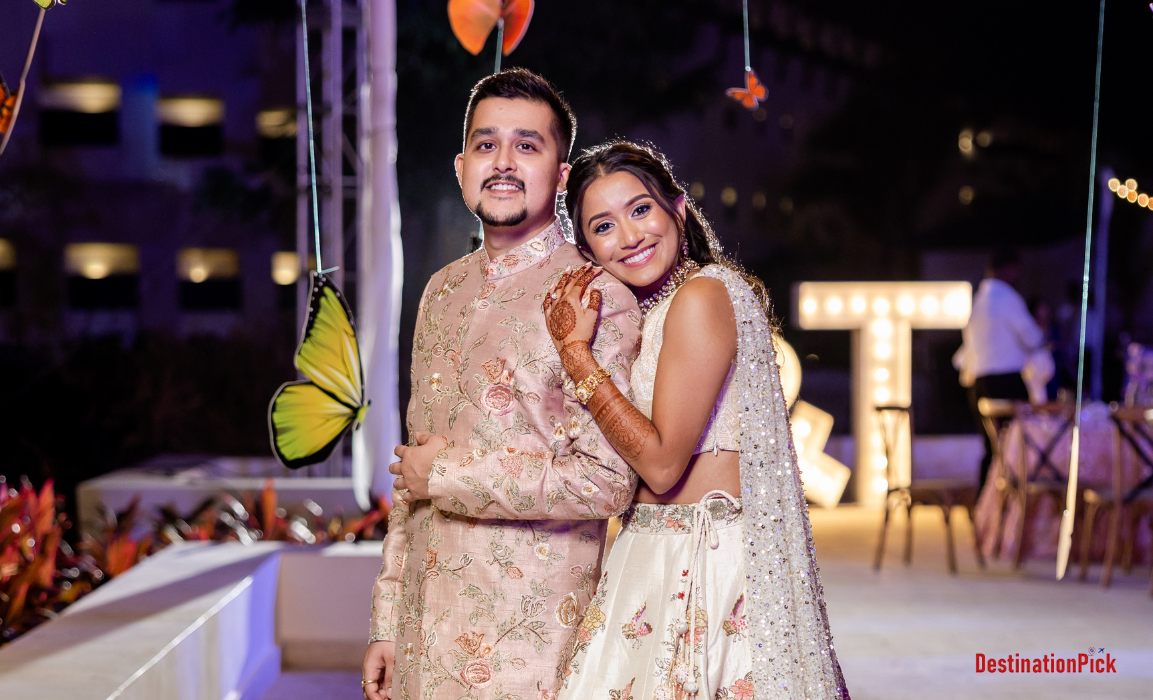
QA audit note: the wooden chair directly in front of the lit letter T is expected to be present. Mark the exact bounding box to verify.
[873,406,985,573]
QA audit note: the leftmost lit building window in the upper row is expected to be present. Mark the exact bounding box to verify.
[39,80,120,146]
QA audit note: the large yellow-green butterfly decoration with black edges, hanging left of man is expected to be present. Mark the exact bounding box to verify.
[269,272,370,469]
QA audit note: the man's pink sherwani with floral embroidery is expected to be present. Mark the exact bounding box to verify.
[371,225,640,700]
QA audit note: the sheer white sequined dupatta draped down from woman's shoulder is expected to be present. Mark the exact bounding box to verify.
[700,265,849,700]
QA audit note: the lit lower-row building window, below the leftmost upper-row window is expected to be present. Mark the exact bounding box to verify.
[65,243,141,309]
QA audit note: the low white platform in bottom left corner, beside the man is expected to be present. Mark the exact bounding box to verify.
[0,541,380,700]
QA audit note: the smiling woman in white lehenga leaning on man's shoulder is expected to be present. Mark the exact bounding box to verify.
[542,142,849,700]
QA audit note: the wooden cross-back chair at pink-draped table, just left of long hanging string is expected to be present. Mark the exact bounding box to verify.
[1009,404,1075,569]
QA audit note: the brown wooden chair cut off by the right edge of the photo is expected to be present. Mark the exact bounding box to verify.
[1080,404,1153,595]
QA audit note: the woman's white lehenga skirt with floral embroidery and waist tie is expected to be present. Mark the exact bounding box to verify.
[557,491,753,700]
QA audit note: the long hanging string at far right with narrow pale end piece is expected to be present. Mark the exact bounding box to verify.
[1057,0,1105,580]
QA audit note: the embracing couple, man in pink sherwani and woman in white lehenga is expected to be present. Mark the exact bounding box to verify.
[362,69,849,700]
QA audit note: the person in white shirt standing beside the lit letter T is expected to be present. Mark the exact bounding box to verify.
[952,250,1045,487]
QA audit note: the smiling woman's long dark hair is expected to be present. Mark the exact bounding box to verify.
[565,140,777,320]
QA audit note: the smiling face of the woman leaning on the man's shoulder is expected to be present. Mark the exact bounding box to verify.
[580,172,685,299]
